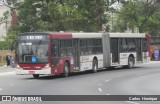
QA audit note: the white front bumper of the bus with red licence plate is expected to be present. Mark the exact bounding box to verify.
[16,68,51,75]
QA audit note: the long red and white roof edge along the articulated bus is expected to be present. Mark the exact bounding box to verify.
[20,32,146,38]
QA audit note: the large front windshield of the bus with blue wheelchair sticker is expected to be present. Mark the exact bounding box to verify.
[16,40,48,63]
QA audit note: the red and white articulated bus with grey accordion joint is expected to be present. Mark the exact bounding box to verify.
[12,32,150,78]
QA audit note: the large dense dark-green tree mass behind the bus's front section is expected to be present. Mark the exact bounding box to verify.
[14,0,110,32]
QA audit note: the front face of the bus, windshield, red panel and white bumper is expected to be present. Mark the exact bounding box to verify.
[15,33,51,77]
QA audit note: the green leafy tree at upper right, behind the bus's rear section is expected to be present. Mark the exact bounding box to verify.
[112,0,160,33]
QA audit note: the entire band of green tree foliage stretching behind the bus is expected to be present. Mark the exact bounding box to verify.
[2,0,160,44]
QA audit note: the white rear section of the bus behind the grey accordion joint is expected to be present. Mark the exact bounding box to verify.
[110,33,150,68]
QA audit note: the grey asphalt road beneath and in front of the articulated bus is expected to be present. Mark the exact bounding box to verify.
[0,63,160,104]
